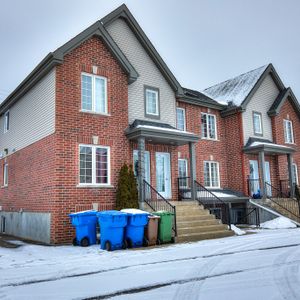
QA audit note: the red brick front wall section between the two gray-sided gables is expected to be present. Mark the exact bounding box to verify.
[178,102,229,187]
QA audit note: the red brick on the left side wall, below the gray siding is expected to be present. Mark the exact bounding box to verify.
[0,135,55,212]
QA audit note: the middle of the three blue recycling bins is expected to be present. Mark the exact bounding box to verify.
[97,210,127,251]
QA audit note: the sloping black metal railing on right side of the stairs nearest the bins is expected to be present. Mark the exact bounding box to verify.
[195,180,231,228]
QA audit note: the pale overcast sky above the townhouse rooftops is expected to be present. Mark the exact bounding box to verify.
[0,0,300,102]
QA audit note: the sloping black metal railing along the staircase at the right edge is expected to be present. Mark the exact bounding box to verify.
[265,182,300,221]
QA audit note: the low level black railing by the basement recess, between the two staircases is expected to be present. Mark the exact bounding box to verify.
[231,207,260,227]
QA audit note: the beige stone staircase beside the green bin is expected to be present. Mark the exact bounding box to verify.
[170,201,234,243]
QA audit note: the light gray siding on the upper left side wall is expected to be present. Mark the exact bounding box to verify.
[0,69,55,154]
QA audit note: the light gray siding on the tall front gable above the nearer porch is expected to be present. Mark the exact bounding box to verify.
[107,19,176,127]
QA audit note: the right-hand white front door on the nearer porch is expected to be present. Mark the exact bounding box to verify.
[155,152,171,199]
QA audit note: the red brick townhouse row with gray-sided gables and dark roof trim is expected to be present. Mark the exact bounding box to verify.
[0,5,300,244]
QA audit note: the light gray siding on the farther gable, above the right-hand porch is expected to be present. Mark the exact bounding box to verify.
[243,75,279,143]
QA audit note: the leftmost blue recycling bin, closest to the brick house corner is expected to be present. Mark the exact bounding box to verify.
[69,210,97,247]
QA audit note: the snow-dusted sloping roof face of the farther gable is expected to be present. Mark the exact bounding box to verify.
[202,65,268,106]
